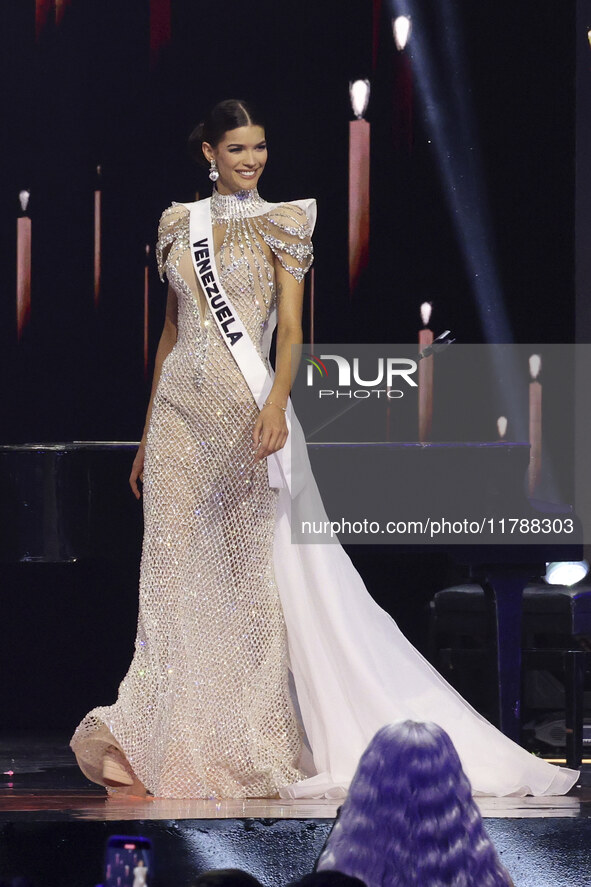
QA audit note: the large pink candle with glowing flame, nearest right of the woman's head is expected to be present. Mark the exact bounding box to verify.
[349,80,370,296]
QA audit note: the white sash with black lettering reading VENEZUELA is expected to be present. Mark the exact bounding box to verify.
[183,198,291,492]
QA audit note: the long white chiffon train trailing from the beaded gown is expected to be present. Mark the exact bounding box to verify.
[274,417,579,798]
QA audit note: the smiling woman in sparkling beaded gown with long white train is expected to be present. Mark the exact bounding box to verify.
[71,101,577,798]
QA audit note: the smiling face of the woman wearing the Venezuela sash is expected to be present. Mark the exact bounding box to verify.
[203,124,267,194]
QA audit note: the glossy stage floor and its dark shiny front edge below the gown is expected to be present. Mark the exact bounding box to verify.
[0,735,591,887]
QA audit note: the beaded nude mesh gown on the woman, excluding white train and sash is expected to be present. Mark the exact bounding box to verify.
[71,191,312,798]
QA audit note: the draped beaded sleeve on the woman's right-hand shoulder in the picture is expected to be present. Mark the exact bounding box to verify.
[260,201,315,282]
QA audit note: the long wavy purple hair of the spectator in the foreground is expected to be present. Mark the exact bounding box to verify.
[317,721,512,887]
